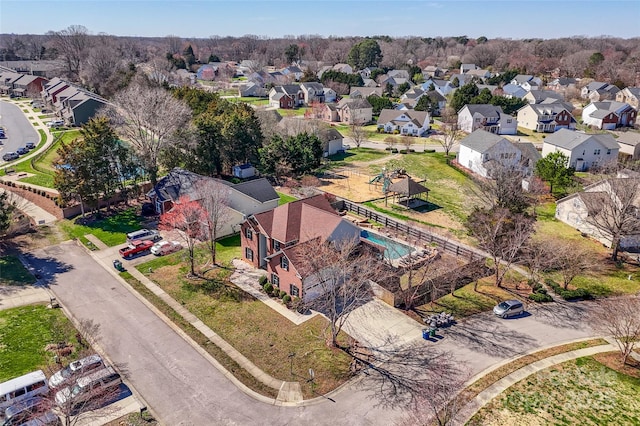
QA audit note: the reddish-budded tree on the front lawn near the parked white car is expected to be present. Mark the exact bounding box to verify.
[158,196,207,275]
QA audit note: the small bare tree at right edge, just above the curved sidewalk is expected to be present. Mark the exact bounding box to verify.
[590,296,640,364]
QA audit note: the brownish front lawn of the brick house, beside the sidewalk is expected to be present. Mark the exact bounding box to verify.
[137,236,350,398]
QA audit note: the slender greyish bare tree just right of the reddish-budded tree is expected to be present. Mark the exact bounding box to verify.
[200,181,231,265]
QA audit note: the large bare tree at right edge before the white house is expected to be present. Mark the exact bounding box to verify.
[581,177,640,260]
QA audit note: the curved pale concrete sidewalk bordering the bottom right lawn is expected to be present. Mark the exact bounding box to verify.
[454,343,616,425]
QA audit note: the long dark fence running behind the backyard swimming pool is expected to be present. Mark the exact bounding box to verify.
[340,199,483,261]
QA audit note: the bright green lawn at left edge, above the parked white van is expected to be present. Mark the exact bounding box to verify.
[0,305,76,382]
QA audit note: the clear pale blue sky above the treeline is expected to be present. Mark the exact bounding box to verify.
[0,0,640,39]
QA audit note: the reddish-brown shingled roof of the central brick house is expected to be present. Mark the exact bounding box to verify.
[254,195,342,243]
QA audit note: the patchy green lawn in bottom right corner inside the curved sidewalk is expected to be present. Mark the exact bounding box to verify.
[468,357,640,425]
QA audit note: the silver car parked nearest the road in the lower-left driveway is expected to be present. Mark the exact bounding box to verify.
[55,367,122,407]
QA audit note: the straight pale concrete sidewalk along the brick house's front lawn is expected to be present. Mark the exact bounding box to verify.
[90,245,303,405]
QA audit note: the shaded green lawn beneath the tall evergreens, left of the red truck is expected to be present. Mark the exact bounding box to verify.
[58,208,143,247]
